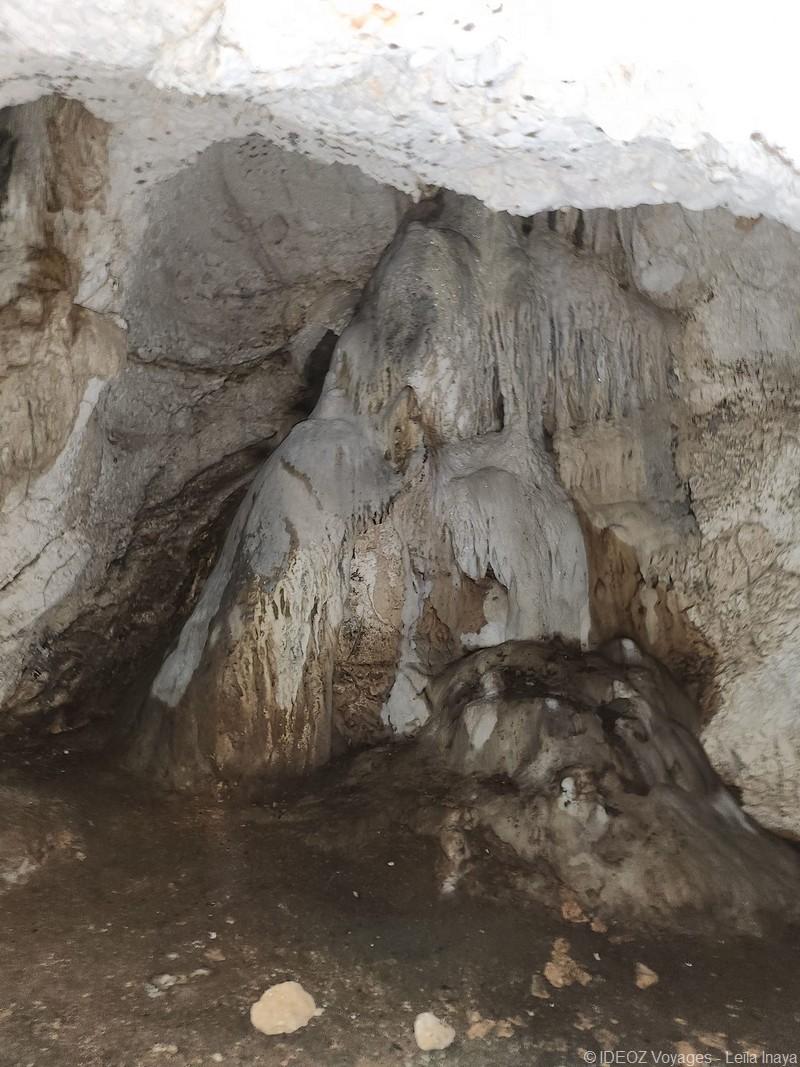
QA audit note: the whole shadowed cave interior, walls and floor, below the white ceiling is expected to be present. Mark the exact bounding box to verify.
[0,94,800,1067]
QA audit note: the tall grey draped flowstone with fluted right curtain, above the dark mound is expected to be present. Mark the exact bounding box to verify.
[131,195,776,819]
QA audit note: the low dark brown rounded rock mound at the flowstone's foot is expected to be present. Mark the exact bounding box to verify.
[422,639,800,929]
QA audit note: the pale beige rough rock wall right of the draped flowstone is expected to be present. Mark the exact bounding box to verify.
[557,207,800,834]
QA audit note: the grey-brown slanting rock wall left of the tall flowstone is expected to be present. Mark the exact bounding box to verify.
[0,98,403,731]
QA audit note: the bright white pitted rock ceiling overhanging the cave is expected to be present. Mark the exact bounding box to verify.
[0,0,800,324]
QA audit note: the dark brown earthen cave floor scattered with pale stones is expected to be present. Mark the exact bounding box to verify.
[0,755,800,1067]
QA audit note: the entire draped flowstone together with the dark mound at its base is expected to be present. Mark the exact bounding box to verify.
[129,187,800,929]
